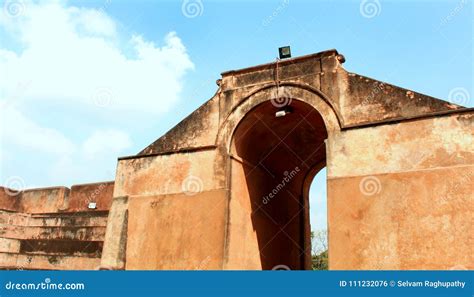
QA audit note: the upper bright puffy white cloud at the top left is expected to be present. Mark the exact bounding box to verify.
[0,2,194,114]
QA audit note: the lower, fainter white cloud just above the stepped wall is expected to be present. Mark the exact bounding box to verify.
[0,107,132,187]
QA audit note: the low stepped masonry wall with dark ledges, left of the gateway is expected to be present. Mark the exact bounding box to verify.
[0,182,114,270]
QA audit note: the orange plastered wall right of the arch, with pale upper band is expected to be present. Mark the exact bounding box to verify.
[328,113,474,269]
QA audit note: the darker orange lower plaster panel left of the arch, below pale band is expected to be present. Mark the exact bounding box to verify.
[125,190,227,270]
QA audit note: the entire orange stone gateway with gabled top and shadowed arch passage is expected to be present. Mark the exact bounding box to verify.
[101,50,474,270]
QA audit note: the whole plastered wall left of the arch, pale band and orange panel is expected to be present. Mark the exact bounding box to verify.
[102,148,228,270]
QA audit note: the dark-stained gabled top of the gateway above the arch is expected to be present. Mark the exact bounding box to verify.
[139,50,462,155]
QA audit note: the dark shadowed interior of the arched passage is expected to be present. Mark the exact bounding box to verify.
[231,100,327,270]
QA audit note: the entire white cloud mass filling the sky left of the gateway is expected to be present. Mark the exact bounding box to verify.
[0,1,194,186]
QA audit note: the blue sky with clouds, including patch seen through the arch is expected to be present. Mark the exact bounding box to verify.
[0,0,474,229]
